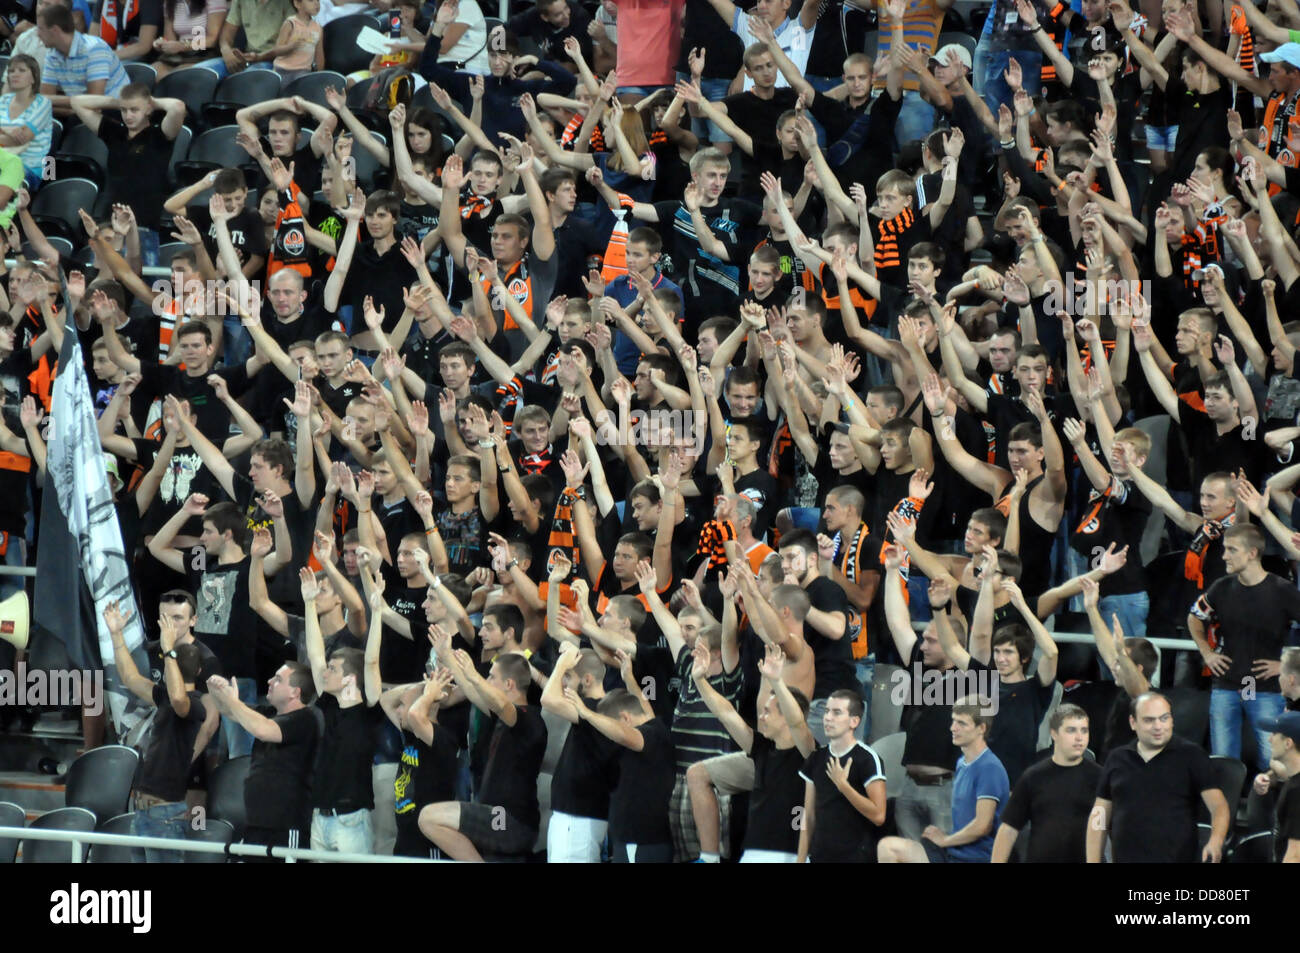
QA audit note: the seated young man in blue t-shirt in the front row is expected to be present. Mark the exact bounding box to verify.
[876,698,1011,863]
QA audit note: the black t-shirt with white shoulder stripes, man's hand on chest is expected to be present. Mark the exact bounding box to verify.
[800,741,885,863]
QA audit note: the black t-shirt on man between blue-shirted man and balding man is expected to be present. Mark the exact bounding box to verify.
[1002,758,1101,863]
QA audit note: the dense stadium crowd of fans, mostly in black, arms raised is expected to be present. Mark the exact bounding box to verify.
[0,0,1300,863]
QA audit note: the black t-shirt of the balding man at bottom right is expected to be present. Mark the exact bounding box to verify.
[1097,735,1214,863]
